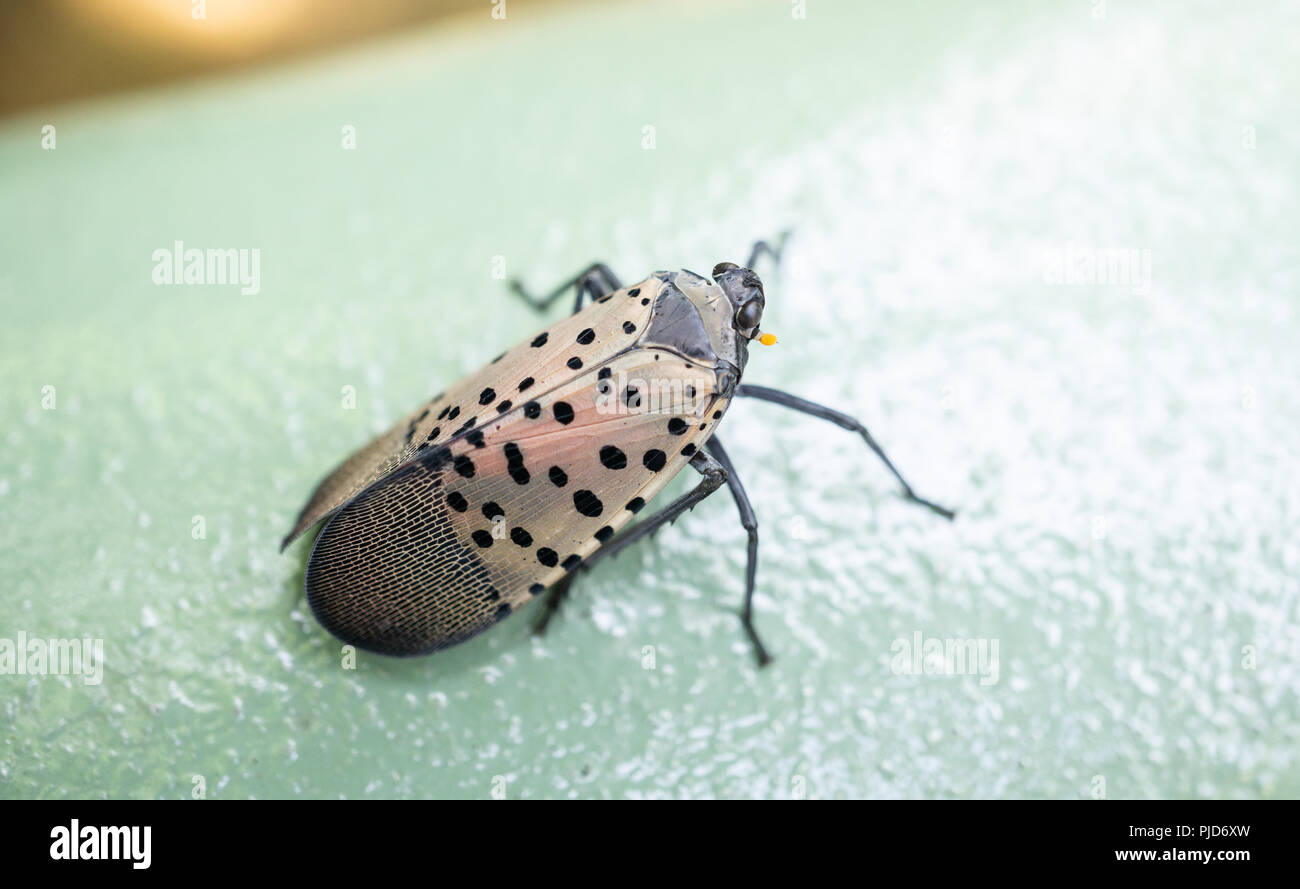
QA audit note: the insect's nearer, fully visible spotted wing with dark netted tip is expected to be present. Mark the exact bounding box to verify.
[307,348,725,655]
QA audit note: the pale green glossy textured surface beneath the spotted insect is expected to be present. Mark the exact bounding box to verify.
[0,1,1300,798]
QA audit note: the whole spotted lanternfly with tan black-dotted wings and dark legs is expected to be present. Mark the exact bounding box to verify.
[281,235,953,664]
